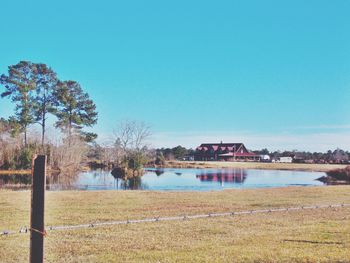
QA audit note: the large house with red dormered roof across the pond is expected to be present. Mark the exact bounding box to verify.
[194,142,260,161]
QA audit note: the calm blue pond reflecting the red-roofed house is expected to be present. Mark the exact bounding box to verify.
[0,168,326,191]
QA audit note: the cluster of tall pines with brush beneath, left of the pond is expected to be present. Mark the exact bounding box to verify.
[0,61,98,168]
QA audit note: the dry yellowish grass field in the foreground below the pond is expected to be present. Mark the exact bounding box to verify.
[0,186,350,262]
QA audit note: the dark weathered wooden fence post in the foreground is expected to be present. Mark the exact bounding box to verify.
[30,155,46,263]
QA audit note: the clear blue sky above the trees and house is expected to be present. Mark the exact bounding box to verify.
[0,0,350,150]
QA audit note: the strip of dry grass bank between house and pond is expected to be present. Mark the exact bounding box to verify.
[164,161,346,172]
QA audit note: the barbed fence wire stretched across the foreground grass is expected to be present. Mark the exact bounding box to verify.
[0,204,350,236]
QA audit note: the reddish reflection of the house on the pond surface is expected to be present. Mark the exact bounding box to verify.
[196,169,247,185]
